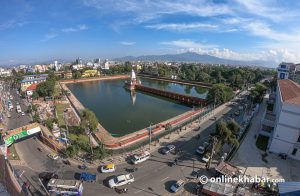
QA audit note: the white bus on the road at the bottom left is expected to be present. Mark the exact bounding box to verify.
[47,178,83,196]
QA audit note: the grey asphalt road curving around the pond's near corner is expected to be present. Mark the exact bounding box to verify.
[10,83,250,196]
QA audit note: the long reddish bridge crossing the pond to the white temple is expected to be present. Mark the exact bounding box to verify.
[135,84,207,106]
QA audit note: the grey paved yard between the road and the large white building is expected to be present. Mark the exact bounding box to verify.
[231,98,300,181]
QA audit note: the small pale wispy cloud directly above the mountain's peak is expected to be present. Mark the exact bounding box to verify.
[160,39,217,48]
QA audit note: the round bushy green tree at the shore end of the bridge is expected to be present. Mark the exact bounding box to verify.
[207,84,234,105]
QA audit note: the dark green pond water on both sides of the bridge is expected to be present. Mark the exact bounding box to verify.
[67,79,209,136]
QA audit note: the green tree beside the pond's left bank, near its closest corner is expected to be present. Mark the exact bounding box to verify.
[80,109,98,132]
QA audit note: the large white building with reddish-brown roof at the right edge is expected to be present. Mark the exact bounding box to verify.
[269,79,300,160]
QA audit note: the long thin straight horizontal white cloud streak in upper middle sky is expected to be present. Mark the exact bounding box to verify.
[145,23,218,31]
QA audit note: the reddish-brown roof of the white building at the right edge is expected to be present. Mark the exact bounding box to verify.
[278,80,300,105]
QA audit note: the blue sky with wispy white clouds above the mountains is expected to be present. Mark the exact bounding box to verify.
[0,0,300,66]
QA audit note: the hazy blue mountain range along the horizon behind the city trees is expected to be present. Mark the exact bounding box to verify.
[113,52,277,67]
